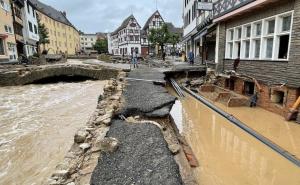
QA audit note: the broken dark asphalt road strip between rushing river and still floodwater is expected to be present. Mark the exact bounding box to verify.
[91,69,183,185]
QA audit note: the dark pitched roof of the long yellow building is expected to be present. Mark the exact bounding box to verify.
[29,0,77,30]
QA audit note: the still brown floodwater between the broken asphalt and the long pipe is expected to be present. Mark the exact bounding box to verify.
[170,90,300,185]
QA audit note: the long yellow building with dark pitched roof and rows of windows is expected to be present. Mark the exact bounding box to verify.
[30,0,80,55]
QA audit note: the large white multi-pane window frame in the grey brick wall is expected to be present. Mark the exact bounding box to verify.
[225,10,294,61]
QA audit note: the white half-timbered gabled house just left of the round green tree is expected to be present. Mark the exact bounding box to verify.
[108,15,141,56]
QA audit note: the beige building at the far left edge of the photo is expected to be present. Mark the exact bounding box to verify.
[0,0,17,62]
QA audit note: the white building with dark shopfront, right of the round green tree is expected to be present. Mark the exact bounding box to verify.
[182,0,217,62]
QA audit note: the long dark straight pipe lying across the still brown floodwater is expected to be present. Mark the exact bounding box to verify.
[183,87,300,167]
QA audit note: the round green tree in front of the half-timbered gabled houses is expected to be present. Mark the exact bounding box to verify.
[148,24,170,57]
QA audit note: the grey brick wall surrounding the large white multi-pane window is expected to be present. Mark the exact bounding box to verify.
[218,0,300,87]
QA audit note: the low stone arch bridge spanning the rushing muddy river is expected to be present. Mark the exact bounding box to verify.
[0,65,119,86]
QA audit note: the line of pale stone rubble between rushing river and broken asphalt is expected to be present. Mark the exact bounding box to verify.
[46,72,126,185]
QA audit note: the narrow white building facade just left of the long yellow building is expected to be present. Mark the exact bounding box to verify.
[23,0,39,57]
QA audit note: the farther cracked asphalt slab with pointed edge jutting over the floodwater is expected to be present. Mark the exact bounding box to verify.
[119,69,176,117]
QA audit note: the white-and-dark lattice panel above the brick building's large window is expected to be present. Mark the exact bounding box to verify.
[214,0,256,19]
